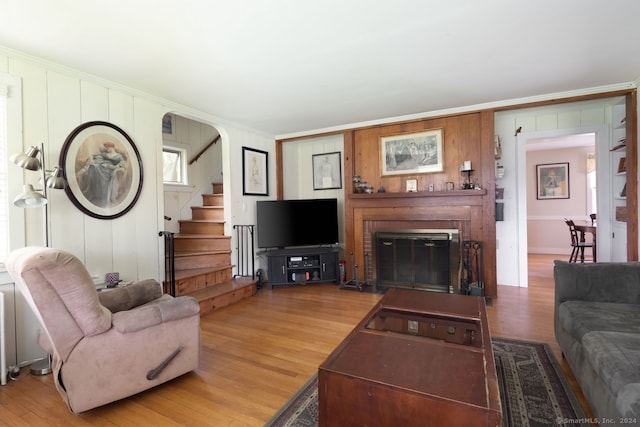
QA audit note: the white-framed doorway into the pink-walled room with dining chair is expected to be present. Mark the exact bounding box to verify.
[517,126,611,286]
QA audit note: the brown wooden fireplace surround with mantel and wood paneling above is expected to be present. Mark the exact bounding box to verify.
[330,110,498,296]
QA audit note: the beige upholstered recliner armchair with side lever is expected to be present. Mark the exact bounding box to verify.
[7,247,200,413]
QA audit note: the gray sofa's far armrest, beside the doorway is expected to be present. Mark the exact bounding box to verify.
[553,260,640,306]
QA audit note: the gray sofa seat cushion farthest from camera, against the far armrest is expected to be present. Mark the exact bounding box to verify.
[558,301,640,342]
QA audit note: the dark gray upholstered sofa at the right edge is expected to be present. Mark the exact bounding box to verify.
[554,261,640,425]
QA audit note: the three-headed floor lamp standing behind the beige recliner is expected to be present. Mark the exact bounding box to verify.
[11,144,67,375]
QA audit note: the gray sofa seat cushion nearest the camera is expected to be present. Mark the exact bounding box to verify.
[582,331,640,416]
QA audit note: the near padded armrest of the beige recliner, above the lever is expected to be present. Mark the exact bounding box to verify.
[111,296,200,334]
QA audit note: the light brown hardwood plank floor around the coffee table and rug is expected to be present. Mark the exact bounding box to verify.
[0,255,590,426]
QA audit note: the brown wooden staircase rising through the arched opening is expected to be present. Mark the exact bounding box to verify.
[164,183,257,315]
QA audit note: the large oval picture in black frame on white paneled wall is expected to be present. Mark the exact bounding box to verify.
[60,121,143,220]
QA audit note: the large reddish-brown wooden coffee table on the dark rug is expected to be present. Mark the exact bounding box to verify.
[318,289,502,426]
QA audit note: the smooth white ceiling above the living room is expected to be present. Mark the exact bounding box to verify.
[0,0,640,136]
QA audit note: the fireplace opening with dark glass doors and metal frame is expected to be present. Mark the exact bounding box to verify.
[373,229,460,292]
